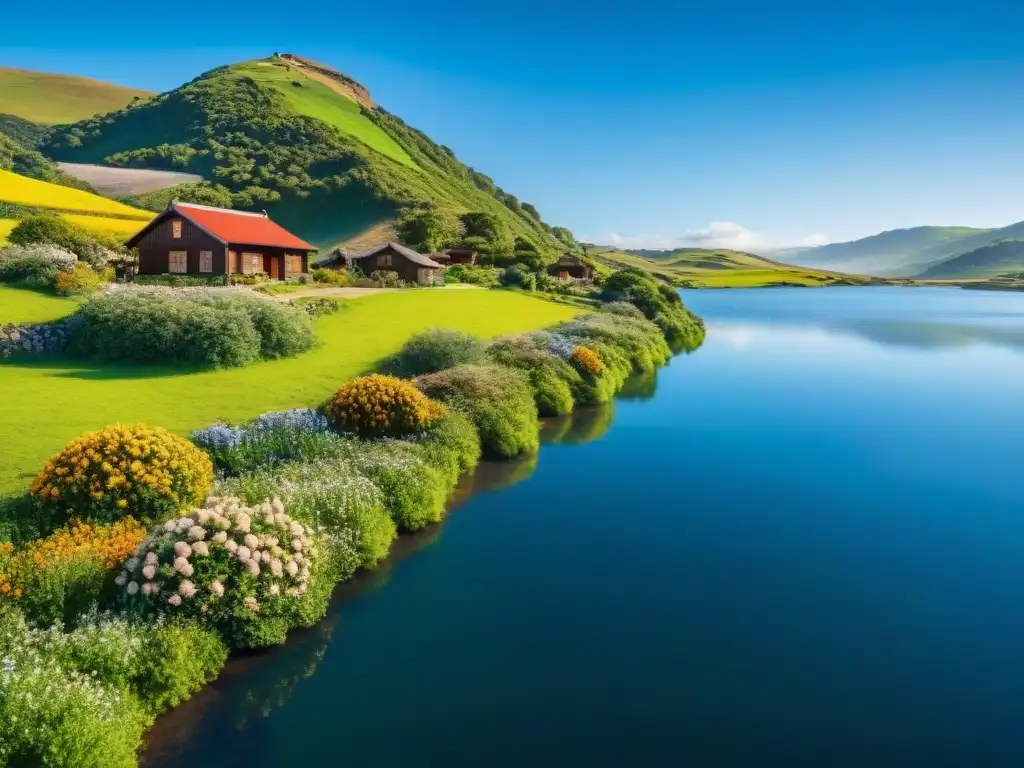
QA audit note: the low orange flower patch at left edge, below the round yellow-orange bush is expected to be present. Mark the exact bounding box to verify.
[0,517,145,600]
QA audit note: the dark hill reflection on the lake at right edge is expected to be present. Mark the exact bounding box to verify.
[827,319,1024,350]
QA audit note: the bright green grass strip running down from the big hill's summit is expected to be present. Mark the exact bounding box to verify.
[231,61,416,168]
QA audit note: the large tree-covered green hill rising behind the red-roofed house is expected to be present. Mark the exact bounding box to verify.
[40,54,569,261]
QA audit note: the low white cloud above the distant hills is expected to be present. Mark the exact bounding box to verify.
[581,221,830,254]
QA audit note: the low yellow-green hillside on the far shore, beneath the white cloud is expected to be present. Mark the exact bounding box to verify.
[588,246,870,288]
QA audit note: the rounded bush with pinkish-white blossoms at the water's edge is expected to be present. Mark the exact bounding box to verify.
[116,497,333,647]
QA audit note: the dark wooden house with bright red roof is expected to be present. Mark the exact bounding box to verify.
[127,201,316,280]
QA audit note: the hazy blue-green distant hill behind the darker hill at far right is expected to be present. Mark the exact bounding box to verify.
[778,226,997,275]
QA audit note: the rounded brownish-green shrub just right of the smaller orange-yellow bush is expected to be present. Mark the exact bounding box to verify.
[416,366,540,458]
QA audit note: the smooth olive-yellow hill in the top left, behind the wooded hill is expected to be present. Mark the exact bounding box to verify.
[0,68,153,125]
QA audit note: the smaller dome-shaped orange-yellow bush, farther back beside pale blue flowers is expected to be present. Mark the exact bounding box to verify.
[326,374,444,437]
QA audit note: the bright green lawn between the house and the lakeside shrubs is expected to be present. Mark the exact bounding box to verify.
[0,290,579,494]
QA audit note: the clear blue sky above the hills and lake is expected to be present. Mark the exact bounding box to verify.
[0,0,1024,250]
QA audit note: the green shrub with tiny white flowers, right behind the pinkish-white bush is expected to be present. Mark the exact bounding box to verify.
[218,457,397,579]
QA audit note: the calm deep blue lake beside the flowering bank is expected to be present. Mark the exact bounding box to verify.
[146,288,1024,768]
